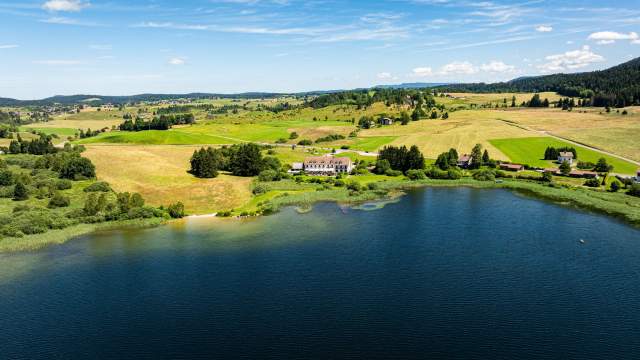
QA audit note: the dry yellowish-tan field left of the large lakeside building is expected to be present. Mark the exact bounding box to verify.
[83,145,252,214]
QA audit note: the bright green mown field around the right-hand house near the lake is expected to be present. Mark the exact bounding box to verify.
[491,137,638,174]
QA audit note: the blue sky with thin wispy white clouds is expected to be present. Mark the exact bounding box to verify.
[0,0,640,99]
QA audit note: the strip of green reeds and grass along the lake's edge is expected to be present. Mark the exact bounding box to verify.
[0,178,640,254]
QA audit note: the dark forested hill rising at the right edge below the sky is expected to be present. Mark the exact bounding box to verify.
[438,58,640,107]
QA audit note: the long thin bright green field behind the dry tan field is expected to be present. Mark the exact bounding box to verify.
[78,130,238,145]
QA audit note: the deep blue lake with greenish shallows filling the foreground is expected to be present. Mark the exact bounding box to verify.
[0,188,640,359]
